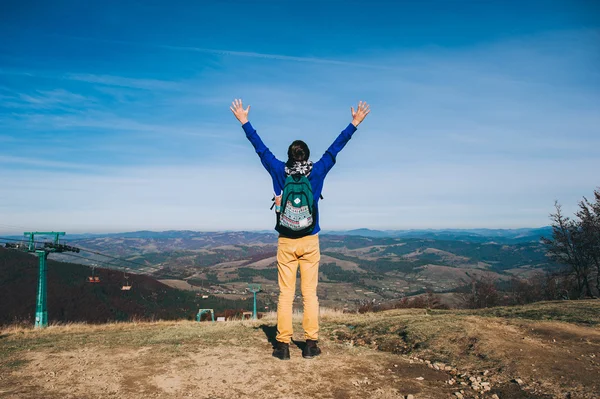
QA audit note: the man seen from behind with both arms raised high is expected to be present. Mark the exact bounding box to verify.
[230,100,370,360]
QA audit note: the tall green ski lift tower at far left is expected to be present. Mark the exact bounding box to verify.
[23,231,79,328]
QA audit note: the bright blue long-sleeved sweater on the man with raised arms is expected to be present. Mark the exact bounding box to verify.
[242,122,356,234]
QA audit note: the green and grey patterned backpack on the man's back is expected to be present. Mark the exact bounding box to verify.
[275,175,317,238]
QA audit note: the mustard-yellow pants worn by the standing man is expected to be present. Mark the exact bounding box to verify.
[277,234,321,344]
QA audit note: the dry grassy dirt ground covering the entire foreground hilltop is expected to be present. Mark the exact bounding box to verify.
[0,304,600,399]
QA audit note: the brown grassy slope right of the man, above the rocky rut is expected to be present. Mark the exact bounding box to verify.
[316,300,600,397]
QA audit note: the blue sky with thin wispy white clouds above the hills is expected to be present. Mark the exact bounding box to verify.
[0,0,600,233]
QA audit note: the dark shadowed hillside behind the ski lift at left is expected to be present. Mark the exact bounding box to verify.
[0,248,251,324]
